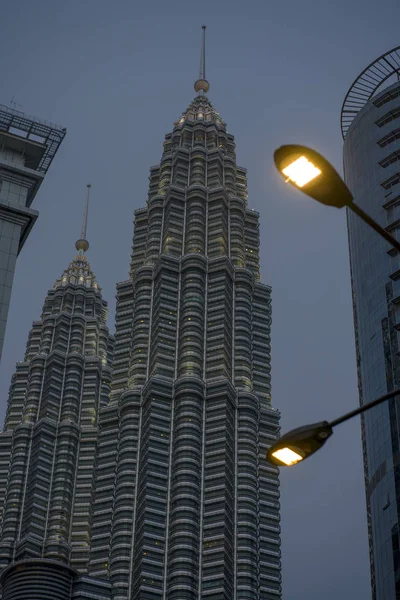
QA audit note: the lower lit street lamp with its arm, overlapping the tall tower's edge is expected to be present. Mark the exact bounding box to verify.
[266,388,400,467]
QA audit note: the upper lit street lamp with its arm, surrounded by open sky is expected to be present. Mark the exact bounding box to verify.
[274,144,400,252]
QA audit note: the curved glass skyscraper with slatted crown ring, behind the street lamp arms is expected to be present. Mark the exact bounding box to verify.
[342,47,400,600]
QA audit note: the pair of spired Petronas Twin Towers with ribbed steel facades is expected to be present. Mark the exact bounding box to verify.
[0,32,281,600]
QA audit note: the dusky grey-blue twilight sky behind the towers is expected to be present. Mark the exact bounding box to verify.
[0,0,400,600]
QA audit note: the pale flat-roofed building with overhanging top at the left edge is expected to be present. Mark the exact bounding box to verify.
[0,105,66,358]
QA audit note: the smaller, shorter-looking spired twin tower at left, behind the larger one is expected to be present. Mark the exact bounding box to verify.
[0,188,114,600]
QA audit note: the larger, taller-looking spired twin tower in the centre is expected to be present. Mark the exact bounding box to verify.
[89,28,281,600]
